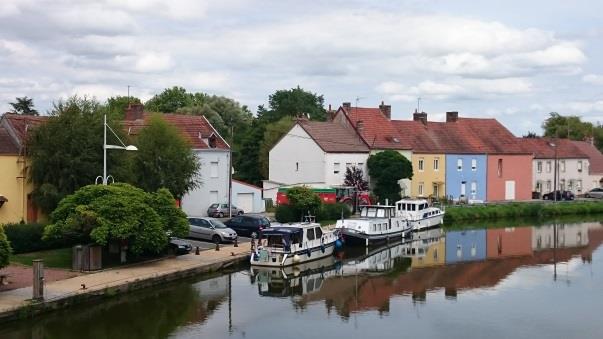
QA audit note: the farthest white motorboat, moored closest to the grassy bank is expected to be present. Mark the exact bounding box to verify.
[396,199,444,230]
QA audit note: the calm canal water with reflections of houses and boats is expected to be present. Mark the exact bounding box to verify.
[0,221,603,339]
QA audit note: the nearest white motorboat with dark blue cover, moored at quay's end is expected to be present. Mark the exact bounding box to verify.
[250,218,339,267]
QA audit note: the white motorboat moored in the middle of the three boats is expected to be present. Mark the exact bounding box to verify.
[335,205,412,246]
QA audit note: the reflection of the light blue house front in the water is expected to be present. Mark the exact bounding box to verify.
[446,230,486,264]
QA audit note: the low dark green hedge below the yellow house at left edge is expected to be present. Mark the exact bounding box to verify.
[4,224,81,253]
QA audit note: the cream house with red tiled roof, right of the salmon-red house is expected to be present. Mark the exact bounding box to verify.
[518,138,590,196]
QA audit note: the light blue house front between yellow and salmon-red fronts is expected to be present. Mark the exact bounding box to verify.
[446,154,488,201]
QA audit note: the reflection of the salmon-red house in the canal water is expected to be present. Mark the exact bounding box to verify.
[486,227,532,259]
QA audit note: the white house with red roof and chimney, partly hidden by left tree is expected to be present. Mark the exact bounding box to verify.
[124,105,231,216]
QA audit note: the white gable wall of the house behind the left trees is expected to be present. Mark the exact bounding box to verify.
[182,149,229,216]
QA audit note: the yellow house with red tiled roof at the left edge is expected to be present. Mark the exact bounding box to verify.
[0,113,46,224]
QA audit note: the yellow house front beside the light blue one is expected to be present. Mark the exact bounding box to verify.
[411,153,446,198]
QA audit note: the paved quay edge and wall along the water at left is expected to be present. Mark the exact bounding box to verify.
[0,243,250,323]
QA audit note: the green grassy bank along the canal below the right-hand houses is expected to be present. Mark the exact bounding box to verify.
[444,201,603,224]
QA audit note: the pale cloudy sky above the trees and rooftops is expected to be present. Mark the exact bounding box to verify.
[0,0,603,135]
